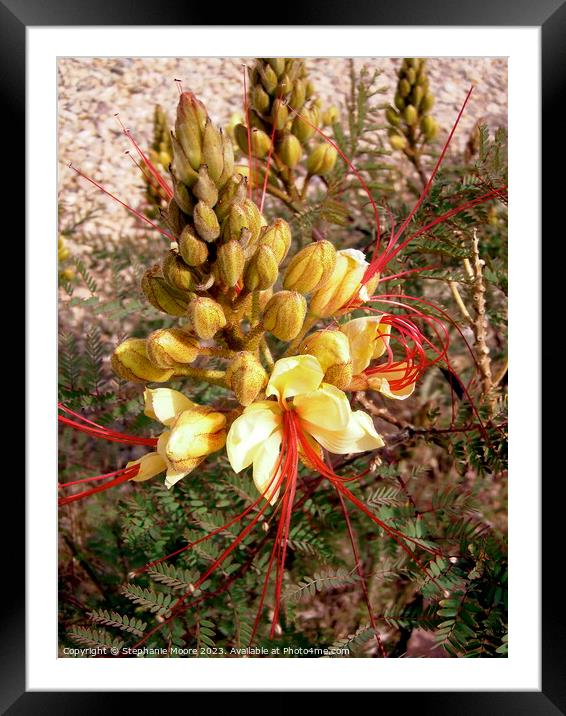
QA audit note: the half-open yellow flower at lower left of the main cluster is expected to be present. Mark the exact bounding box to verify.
[127,388,226,487]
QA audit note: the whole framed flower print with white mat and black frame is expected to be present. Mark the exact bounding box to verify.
[12,2,566,714]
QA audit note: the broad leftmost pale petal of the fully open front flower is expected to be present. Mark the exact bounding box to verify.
[226,400,281,472]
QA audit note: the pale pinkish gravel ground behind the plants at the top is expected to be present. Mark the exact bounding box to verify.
[59,57,507,239]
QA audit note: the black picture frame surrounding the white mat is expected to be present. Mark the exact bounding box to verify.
[14,0,566,716]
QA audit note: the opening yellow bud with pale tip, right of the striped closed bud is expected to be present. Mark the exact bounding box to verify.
[310,249,369,318]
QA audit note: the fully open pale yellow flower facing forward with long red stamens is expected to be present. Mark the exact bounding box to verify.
[226,355,384,504]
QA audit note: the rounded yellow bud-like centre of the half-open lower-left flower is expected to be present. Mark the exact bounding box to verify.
[165,404,226,472]
